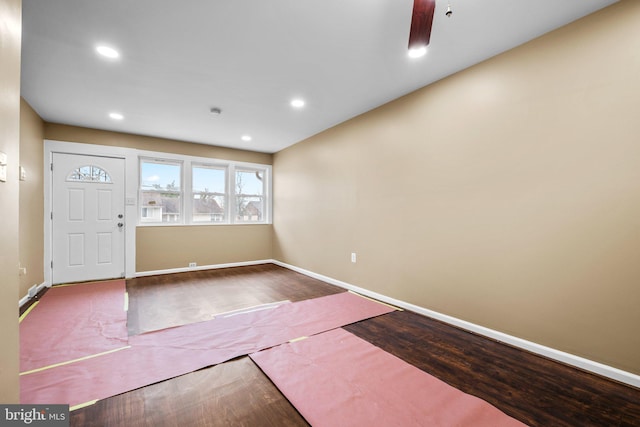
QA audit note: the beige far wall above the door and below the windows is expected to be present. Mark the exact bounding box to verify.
[45,123,273,272]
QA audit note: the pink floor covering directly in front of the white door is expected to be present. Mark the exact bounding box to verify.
[20,280,128,372]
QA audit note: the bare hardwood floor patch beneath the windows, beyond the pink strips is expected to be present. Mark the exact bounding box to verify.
[127,264,344,335]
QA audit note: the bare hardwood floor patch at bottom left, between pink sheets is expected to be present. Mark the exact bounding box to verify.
[71,357,309,427]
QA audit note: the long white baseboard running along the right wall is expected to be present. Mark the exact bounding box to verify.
[270,260,640,388]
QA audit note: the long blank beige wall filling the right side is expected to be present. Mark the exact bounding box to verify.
[274,0,640,374]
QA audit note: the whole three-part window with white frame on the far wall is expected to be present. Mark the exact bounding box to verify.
[138,153,271,225]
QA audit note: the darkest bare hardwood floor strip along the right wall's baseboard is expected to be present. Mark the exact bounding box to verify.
[344,311,640,427]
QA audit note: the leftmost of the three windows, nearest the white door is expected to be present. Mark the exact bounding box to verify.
[140,161,182,223]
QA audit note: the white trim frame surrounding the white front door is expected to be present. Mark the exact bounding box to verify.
[43,140,138,286]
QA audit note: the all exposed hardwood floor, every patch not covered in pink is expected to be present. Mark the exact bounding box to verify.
[56,264,640,426]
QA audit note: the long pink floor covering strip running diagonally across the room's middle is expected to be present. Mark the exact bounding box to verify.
[20,292,394,406]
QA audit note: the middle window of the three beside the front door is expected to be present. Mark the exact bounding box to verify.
[192,166,227,222]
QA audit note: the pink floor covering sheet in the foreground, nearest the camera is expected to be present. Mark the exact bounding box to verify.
[250,329,524,427]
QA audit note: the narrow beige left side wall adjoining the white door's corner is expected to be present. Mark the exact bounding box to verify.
[19,99,44,297]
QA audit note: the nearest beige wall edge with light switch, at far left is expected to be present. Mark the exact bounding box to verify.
[0,0,22,403]
